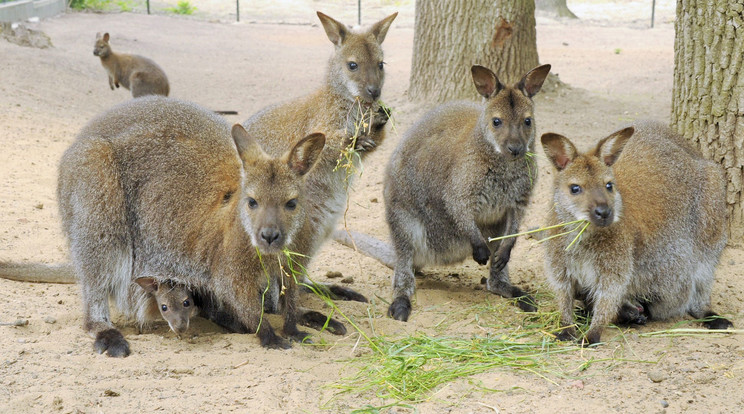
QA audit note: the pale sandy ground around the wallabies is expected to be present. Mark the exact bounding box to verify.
[0,1,744,413]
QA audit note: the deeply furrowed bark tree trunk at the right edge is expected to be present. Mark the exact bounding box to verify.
[672,0,744,245]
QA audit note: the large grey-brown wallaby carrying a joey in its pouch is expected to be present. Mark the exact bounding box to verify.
[58,96,325,357]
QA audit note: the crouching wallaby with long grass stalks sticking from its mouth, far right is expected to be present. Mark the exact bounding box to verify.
[541,122,732,344]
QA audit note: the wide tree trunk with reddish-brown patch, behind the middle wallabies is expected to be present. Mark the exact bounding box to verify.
[408,0,538,102]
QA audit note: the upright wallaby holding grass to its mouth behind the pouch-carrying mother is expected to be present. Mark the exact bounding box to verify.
[237,12,398,310]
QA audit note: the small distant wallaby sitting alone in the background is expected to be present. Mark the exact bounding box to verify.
[93,33,170,98]
